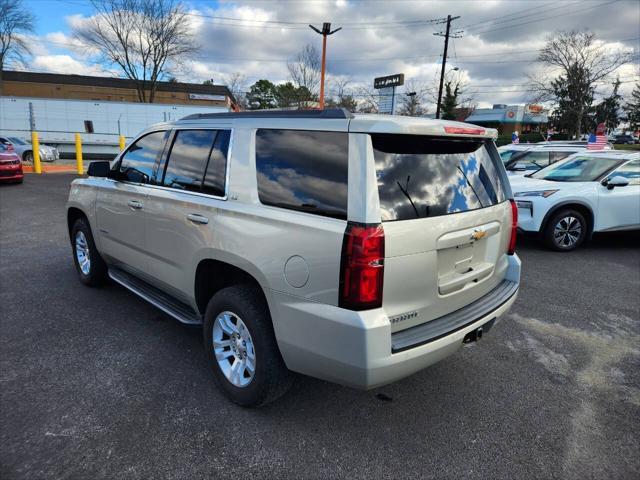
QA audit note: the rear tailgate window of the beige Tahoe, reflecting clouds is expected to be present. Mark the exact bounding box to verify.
[371,134,506,221]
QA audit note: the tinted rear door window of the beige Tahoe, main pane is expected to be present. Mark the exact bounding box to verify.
[163,130,217,192]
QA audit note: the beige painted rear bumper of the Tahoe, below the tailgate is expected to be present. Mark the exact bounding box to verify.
[271,255,520,389]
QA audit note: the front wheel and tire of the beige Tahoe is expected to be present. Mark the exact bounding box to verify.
[71,218,108,287]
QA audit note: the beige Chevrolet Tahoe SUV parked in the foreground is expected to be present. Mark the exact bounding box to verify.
[68,110,520,406]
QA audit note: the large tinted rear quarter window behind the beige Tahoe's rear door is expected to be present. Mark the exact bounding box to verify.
[256,130,349,219]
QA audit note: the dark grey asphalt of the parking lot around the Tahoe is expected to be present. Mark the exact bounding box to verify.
[0,174,640,480]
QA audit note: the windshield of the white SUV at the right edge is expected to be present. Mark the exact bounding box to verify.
[531,155,621,182]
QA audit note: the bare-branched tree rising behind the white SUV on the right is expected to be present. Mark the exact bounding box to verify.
[530,30,631,137]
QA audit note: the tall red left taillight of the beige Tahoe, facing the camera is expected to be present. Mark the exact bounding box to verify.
[339,223,384,310]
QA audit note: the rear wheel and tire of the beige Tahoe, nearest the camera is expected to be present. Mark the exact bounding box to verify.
[203,285,293,407]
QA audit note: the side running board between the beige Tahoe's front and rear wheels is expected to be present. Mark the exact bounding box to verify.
[109,267,202,325]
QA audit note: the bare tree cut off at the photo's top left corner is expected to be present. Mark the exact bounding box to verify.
[0,0,35,81]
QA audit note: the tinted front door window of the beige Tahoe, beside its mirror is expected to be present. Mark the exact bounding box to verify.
[120,132,167,183]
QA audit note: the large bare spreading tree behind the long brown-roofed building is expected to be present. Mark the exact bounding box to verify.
[74,0,199,103]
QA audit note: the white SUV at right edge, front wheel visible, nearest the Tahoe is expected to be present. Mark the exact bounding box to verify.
[510,150,640,252]
